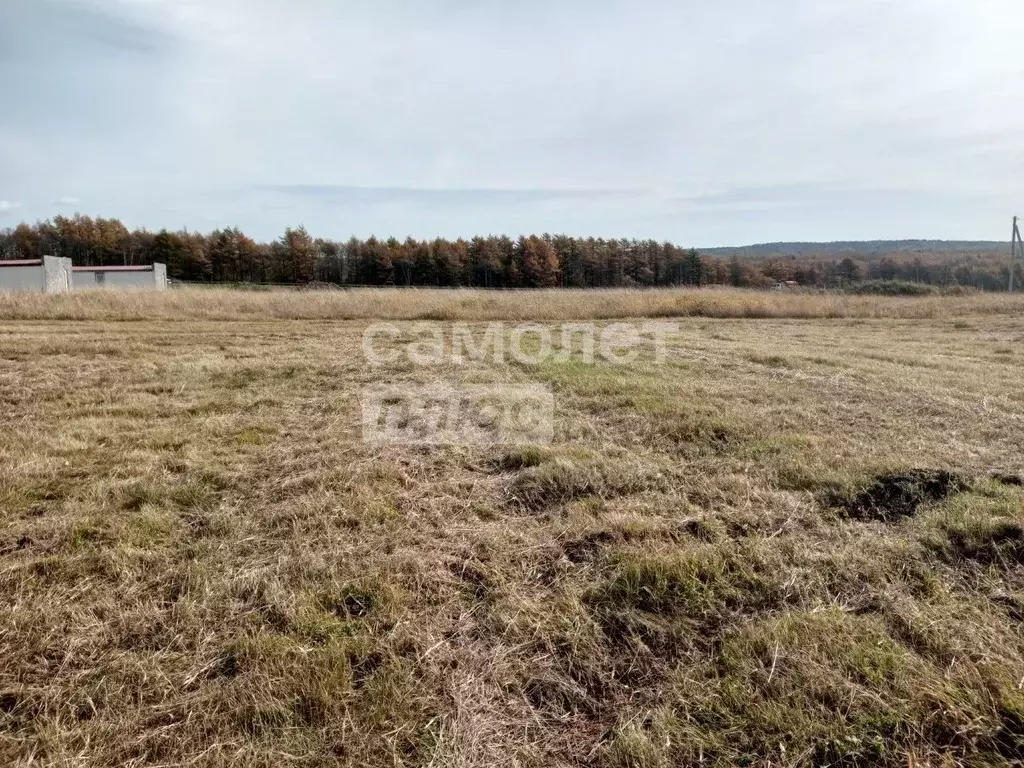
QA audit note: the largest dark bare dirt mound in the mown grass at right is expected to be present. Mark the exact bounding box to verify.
[839,469,971,522]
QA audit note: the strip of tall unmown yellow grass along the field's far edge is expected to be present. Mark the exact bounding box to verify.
[0,288,1024,322]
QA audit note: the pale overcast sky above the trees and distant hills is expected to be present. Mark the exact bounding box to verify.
[0,0,1024,246]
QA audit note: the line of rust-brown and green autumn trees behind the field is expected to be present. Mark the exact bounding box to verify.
[0,215,1024,291]
